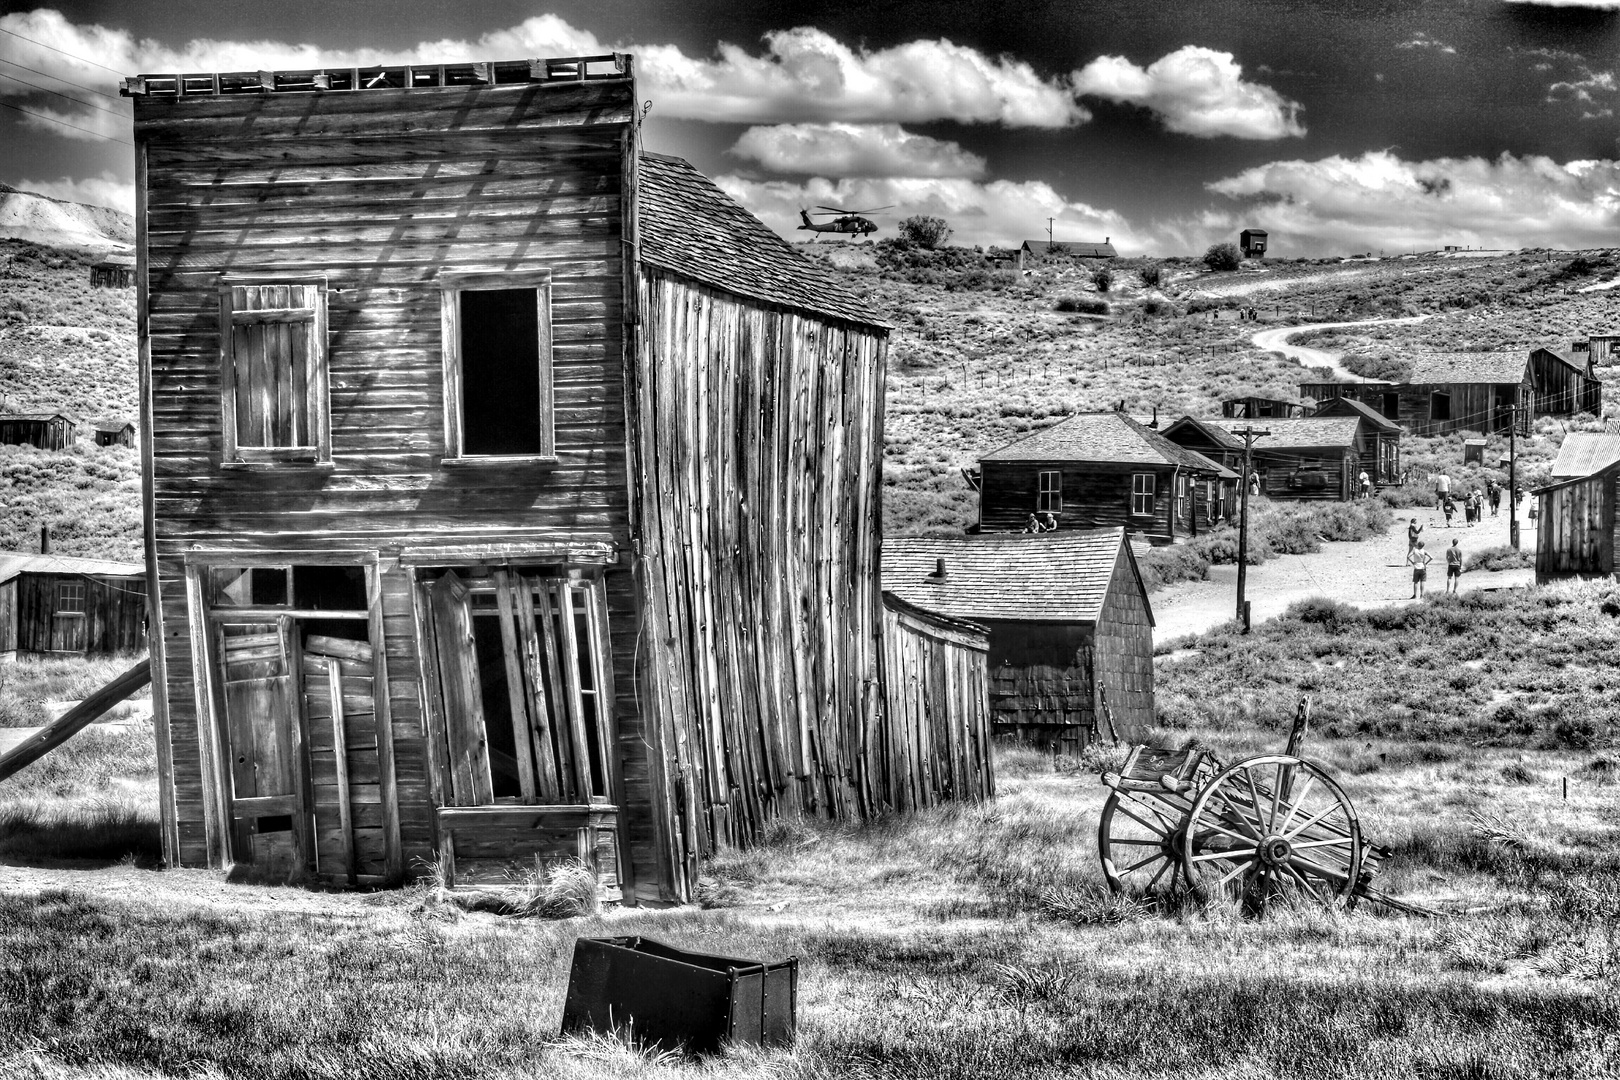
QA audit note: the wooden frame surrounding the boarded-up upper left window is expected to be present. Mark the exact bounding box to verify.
[219,274,332,468]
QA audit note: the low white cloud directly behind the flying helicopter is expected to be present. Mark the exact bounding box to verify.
[716,176,1134,254]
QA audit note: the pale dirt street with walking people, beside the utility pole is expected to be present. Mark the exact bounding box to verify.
[1152,500,1536,641]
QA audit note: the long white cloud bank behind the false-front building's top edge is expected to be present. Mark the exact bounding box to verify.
[0,8,1090,146]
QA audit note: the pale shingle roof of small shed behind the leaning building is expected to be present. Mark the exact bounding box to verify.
[883,528,1153,623]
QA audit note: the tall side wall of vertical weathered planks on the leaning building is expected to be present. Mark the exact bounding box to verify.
[627,267,899,897]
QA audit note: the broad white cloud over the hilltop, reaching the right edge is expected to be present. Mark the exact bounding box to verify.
[1209,151,1620,251]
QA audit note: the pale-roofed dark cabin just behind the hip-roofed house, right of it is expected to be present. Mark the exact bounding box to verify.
[1205,416,1366,502]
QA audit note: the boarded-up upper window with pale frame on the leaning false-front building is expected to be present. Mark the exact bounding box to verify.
[219,280,332,465]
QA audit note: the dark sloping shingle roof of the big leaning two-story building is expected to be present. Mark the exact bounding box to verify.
[640,152,888,329]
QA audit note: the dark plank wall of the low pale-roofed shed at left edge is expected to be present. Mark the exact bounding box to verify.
[10,572,146,656]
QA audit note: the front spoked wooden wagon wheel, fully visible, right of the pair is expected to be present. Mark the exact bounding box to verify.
[1181,755,1362,915]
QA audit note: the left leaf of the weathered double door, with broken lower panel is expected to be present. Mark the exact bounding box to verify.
[215,619,309,881]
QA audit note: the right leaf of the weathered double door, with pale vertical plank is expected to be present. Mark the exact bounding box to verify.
[301,635,387,884]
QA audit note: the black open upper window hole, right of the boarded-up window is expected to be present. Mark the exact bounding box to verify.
[460,288,541,455]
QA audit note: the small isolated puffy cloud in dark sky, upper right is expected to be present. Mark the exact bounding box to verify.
[1072,45,1306,139]
